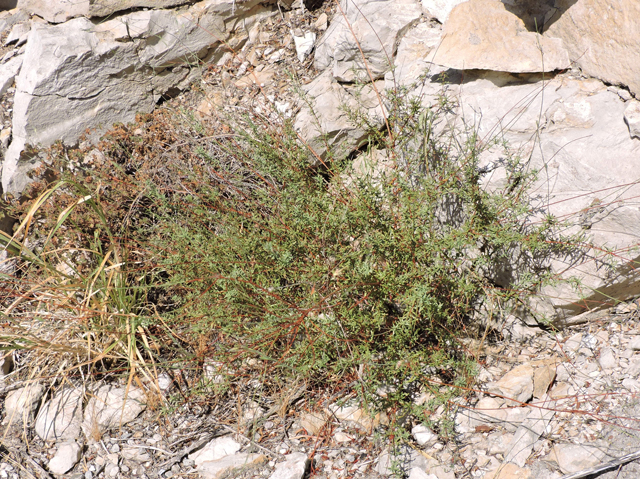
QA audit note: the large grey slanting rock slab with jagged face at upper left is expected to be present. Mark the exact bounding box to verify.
[2,0,269,194]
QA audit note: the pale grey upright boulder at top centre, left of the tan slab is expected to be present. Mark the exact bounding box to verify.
[315,0,422,82]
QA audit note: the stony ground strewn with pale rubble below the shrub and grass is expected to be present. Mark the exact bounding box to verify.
[0,303,640,478]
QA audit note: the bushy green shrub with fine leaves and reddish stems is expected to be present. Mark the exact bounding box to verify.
[149,81,576,412]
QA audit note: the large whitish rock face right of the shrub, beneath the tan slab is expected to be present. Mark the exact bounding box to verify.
[458,72,640,326]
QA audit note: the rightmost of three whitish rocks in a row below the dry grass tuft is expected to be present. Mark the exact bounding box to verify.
[82,385,146,436]
